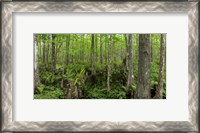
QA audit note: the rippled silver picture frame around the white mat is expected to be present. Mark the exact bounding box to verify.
[1,0,199,132]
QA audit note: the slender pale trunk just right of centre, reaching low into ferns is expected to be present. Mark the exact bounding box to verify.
[107,35,112,95]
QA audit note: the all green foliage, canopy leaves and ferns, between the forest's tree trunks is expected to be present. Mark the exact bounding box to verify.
[34,34,166,99]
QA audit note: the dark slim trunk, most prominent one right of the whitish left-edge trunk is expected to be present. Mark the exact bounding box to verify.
[52,34,56,72]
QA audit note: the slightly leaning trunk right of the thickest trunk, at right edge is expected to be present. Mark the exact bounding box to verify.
[154,34,165,99]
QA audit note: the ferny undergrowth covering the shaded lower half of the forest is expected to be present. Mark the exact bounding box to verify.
[34,63,166,99]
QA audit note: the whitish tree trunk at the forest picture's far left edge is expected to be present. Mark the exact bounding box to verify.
[34,34,40,91]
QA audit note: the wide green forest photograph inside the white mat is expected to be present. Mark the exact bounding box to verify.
[33,33,167,99]
